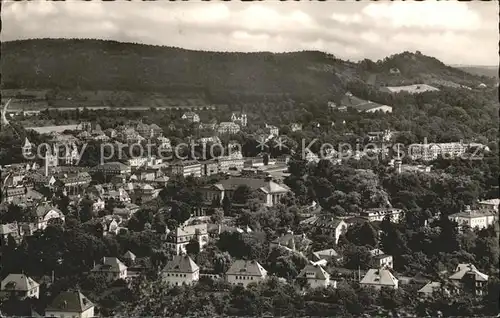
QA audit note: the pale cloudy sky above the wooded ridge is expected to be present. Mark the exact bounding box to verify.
[0,0,499,65]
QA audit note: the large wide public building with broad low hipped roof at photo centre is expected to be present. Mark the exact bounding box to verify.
[200,177,289,206]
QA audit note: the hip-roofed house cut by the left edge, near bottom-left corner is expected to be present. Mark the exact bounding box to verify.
[0,274,40,299]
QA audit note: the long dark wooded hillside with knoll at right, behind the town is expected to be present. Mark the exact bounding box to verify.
[1,39,487,107]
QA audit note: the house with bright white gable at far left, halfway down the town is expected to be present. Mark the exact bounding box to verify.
[20,202,65,236]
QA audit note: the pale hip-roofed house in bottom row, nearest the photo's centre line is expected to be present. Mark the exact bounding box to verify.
[226,260,267,287]
